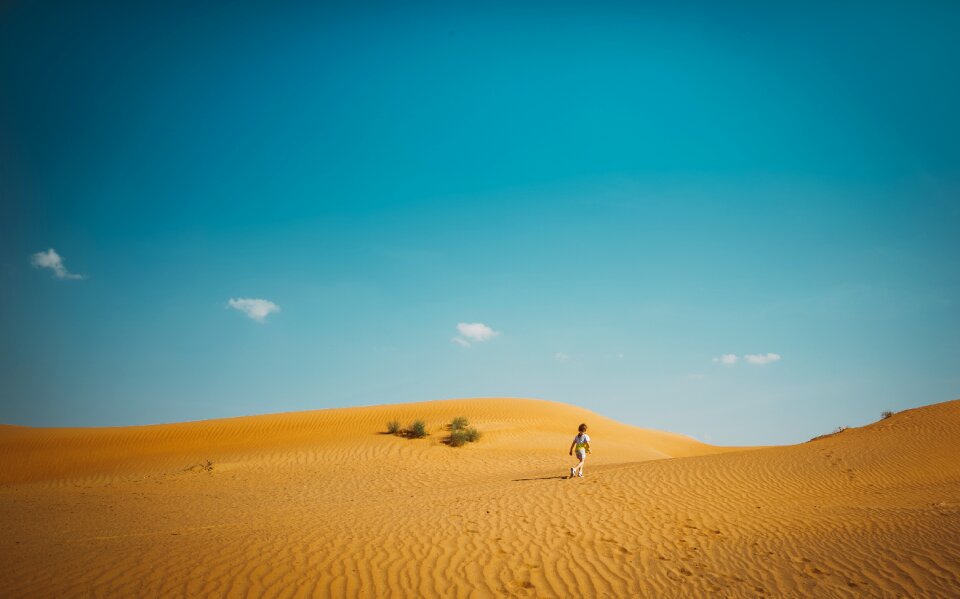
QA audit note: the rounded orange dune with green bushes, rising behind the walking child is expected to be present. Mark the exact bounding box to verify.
[0,398,723,483]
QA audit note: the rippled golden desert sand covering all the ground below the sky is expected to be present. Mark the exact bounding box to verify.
[0,399,960,597]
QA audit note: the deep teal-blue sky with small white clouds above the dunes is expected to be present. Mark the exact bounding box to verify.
[0,2,960,444]
